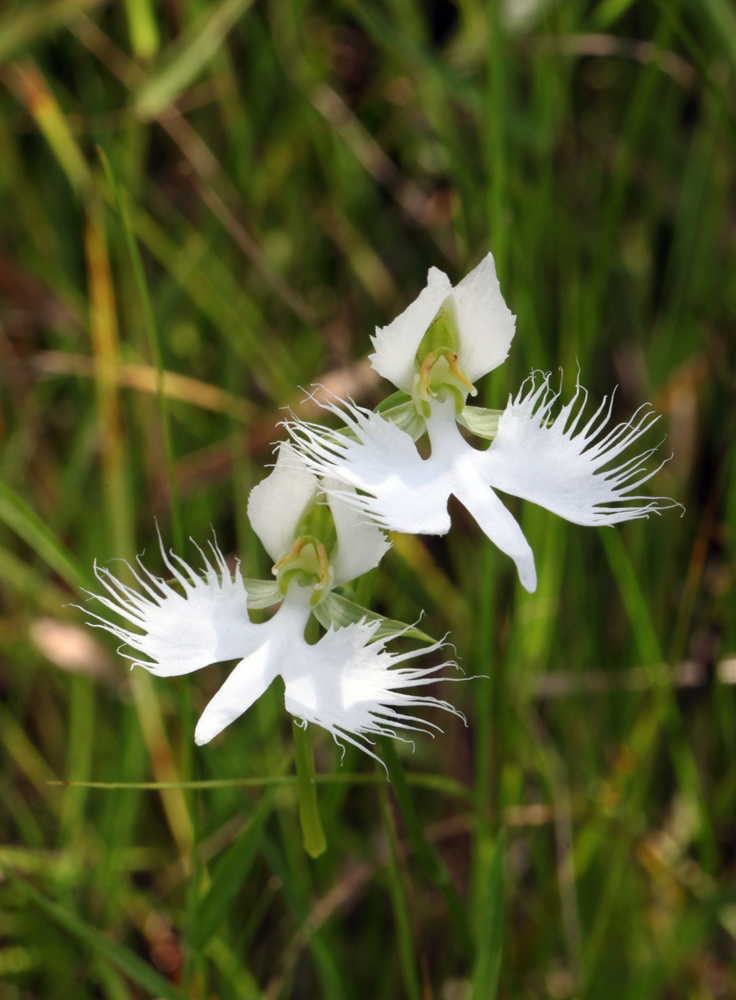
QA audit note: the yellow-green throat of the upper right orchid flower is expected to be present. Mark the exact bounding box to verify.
[411,298,478,419]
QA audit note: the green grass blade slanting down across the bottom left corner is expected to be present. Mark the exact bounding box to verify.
[0,866,182,1000]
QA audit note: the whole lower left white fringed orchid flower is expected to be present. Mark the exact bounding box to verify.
[82,444,459,756]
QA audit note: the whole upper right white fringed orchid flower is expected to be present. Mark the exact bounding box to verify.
[287,254,674,593]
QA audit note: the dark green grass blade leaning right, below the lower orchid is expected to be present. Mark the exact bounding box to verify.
[189,793,273,950]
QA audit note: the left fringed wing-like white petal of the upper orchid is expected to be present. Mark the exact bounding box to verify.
[286,396,452,535]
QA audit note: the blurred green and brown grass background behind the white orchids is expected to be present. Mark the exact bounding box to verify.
[0,0,736,1000]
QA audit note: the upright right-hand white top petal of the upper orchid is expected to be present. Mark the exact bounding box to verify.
[452,253,516,382]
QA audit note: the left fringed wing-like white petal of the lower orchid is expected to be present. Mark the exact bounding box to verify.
[82,538,259,677]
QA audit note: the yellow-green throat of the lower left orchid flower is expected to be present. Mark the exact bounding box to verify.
[271,502,337,607]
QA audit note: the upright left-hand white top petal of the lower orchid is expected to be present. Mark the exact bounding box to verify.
[248,441,319,563]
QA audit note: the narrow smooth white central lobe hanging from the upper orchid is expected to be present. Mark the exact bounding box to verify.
[453,452,537,594]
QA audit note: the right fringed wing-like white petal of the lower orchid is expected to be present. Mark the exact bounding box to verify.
[282,622,463,759]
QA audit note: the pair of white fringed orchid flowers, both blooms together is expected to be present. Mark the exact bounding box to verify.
[85,254,672,756]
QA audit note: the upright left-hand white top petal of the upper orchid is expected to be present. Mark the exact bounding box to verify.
[369,267,452,392]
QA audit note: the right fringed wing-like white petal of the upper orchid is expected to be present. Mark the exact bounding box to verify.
[478,374,677,525]
